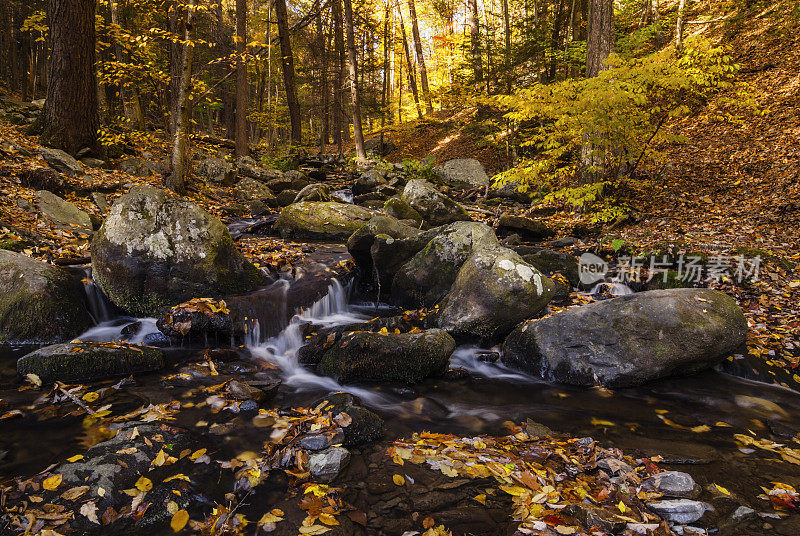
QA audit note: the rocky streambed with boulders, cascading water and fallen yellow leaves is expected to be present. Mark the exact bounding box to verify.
[0,155,800,535]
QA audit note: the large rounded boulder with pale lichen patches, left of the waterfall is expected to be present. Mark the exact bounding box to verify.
[92,186,265,316]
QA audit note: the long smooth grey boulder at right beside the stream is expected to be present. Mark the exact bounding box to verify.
[503,289,747,387]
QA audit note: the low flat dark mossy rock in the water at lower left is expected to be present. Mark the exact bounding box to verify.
[17,342,164,383]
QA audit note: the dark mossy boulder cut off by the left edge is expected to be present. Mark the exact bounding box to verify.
[0,250,93,343]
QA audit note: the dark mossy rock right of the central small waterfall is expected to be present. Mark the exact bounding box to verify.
[319,329,456,384]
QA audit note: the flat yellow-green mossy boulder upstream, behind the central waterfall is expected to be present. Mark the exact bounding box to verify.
[274,202,373,241]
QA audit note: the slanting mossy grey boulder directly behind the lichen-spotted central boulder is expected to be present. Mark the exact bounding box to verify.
[392,222,498,309]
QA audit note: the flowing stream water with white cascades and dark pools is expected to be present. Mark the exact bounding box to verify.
[0,262,800,535]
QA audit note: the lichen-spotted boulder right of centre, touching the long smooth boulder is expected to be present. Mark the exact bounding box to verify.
[437,245,555,339]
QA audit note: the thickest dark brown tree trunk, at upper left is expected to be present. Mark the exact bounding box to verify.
[40,0,99,154]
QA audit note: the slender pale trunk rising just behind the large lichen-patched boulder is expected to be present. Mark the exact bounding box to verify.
[165,0,195,193]
